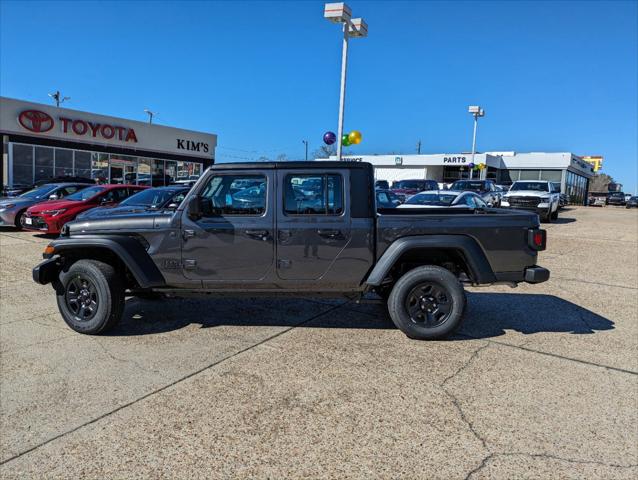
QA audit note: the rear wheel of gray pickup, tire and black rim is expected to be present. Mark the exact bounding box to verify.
[388,265,466,340]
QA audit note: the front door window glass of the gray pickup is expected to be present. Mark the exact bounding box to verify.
[202,174,266,216]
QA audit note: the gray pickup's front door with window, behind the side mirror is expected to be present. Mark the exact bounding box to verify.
[182,170,275,287]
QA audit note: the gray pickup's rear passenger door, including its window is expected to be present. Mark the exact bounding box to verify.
[277,170,351,280]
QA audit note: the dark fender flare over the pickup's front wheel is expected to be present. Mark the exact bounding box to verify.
[50,235,166,288]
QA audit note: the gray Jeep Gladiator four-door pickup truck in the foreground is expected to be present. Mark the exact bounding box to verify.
[33,161,549,339]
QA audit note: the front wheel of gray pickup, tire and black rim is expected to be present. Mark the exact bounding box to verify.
[55,260,124,335]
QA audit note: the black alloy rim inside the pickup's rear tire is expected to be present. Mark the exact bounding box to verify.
[405,282,452,328]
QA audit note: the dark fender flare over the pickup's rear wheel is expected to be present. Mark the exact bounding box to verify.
[365,235,496,287]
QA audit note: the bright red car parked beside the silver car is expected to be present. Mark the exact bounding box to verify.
[22,185,148,233]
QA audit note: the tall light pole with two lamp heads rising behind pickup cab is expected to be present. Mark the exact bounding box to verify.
[323,2,368,160]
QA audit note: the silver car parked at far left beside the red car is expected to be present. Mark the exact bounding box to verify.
[0,183,91,229]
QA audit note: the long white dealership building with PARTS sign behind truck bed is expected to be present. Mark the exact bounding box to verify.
[330,152,594,204]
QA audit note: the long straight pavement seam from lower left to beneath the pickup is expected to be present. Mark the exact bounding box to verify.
[0,300,349,465]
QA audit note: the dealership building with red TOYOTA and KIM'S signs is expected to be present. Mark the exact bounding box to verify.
[0,97,217,186]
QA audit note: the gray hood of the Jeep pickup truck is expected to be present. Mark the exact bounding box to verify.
[65,211,174,235]
